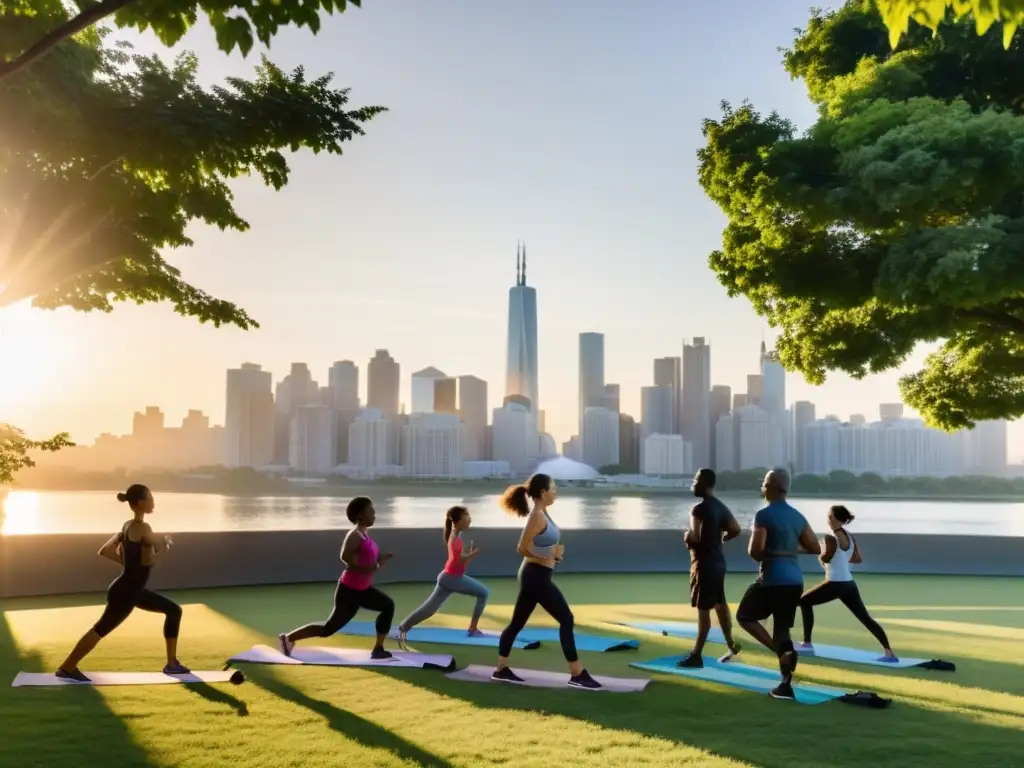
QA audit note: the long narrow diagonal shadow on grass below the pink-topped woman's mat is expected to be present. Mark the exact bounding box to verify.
[246,665,452,768]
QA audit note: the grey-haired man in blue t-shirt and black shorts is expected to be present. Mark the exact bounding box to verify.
[736,469,821,699]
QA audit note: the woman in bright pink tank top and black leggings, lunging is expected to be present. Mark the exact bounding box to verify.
[278,496,394,658]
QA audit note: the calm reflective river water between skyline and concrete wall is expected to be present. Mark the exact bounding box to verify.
[0,490,1024,537]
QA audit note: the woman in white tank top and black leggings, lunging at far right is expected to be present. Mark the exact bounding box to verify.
[800,505,896,660]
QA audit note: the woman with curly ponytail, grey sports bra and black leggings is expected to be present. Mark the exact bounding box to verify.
[490,473,601,689]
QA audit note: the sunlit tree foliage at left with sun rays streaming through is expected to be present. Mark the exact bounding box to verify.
[0,7,383,479]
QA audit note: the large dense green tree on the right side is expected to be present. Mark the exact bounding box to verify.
[698,0,1024,429]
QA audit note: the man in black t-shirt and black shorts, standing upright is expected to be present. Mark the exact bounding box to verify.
[678,469,740,669]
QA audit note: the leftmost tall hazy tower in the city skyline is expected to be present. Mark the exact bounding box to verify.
[224,362,275,467]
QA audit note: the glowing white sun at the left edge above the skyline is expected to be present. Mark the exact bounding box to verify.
[0,301,78,411]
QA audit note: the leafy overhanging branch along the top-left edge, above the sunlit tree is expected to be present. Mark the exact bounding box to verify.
[0,0,361,80]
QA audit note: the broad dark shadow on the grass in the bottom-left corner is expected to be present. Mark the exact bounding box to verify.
[0,614,152,768]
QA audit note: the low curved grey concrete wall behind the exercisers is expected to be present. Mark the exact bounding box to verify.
[0,528,1024,597]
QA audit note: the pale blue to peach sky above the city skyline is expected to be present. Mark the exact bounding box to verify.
[0,0,1024,460]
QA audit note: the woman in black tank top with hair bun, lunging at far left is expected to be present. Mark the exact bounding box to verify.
[56,484,189,683]
